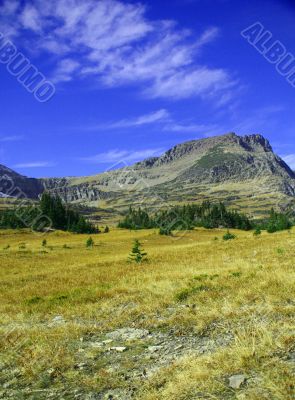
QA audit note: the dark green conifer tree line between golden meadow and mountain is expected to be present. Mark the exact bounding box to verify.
[0,196,293,235]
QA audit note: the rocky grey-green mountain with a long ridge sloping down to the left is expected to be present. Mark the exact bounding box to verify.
[0,133,295,216]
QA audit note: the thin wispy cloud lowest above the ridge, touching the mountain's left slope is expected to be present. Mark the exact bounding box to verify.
[79,148,164,164]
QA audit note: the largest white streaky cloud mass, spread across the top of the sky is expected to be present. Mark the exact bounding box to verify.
[0,0,236,99]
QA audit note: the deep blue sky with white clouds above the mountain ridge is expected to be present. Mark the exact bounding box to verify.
[0,0,295,177]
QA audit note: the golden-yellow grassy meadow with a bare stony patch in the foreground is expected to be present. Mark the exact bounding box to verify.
[0,230,295,400]
